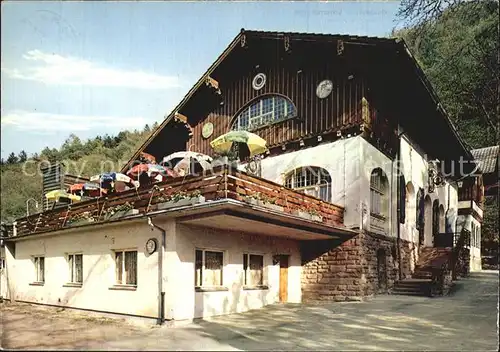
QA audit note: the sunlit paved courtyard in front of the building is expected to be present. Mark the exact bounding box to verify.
[1,271,498,351]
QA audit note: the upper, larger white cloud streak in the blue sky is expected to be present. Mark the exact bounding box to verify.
[2,50,180,89]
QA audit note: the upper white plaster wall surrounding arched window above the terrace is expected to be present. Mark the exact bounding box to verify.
[254,136,364,227]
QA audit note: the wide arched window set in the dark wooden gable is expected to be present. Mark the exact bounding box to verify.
[231,95,297,131]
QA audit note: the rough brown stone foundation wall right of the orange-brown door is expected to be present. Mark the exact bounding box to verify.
[301,233,416,302]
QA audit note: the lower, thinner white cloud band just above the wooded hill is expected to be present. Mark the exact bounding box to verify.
[1,110,147,133]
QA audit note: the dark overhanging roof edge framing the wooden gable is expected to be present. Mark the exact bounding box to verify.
[122,29,472,171]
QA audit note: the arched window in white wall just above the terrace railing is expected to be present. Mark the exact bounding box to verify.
[285,166,332,202]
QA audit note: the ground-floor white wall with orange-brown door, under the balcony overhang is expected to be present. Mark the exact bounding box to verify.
[172,225,301,320]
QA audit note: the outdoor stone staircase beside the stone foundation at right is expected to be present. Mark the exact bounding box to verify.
[391,247,452,296]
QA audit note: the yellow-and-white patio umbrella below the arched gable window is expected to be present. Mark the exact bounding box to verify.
[210,131,267,156]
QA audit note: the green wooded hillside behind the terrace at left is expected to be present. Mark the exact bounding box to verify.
[0,124,154,222]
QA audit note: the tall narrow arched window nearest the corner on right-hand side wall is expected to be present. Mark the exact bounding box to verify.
[370,168,389,232]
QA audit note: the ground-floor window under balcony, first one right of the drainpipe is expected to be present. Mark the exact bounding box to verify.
[195,249,224,287]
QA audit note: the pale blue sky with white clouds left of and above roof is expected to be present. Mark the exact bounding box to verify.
[1,1,399,158]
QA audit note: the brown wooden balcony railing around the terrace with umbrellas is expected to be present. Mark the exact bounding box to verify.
[8,166,344,236]
